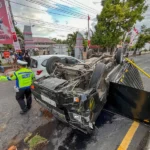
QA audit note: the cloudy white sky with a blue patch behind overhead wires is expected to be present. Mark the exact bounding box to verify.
[10,0,150,39]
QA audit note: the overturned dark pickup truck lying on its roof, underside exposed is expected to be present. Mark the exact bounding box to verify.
[32,50,146,133]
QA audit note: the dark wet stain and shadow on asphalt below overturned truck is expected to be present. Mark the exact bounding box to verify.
[18,111,113,150]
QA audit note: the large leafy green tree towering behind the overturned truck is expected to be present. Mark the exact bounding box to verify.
[91,0,147,52]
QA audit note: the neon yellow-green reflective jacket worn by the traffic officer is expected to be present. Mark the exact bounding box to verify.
[0,68,35,89]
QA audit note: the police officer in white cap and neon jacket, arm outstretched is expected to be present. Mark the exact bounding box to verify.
[0,60,34,114]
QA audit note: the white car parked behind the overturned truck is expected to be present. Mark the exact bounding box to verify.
[30,55,82,79]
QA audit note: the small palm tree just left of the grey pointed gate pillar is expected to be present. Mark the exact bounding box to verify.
[67,31,78,56]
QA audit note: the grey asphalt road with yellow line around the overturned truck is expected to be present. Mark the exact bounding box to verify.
[0,54,150,150]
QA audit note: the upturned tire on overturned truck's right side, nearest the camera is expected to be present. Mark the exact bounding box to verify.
[89,63,106,89]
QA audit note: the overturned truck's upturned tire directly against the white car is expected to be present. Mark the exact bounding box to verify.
[46,56,61,74]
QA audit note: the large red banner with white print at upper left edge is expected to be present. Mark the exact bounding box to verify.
[0,0,13,44]
